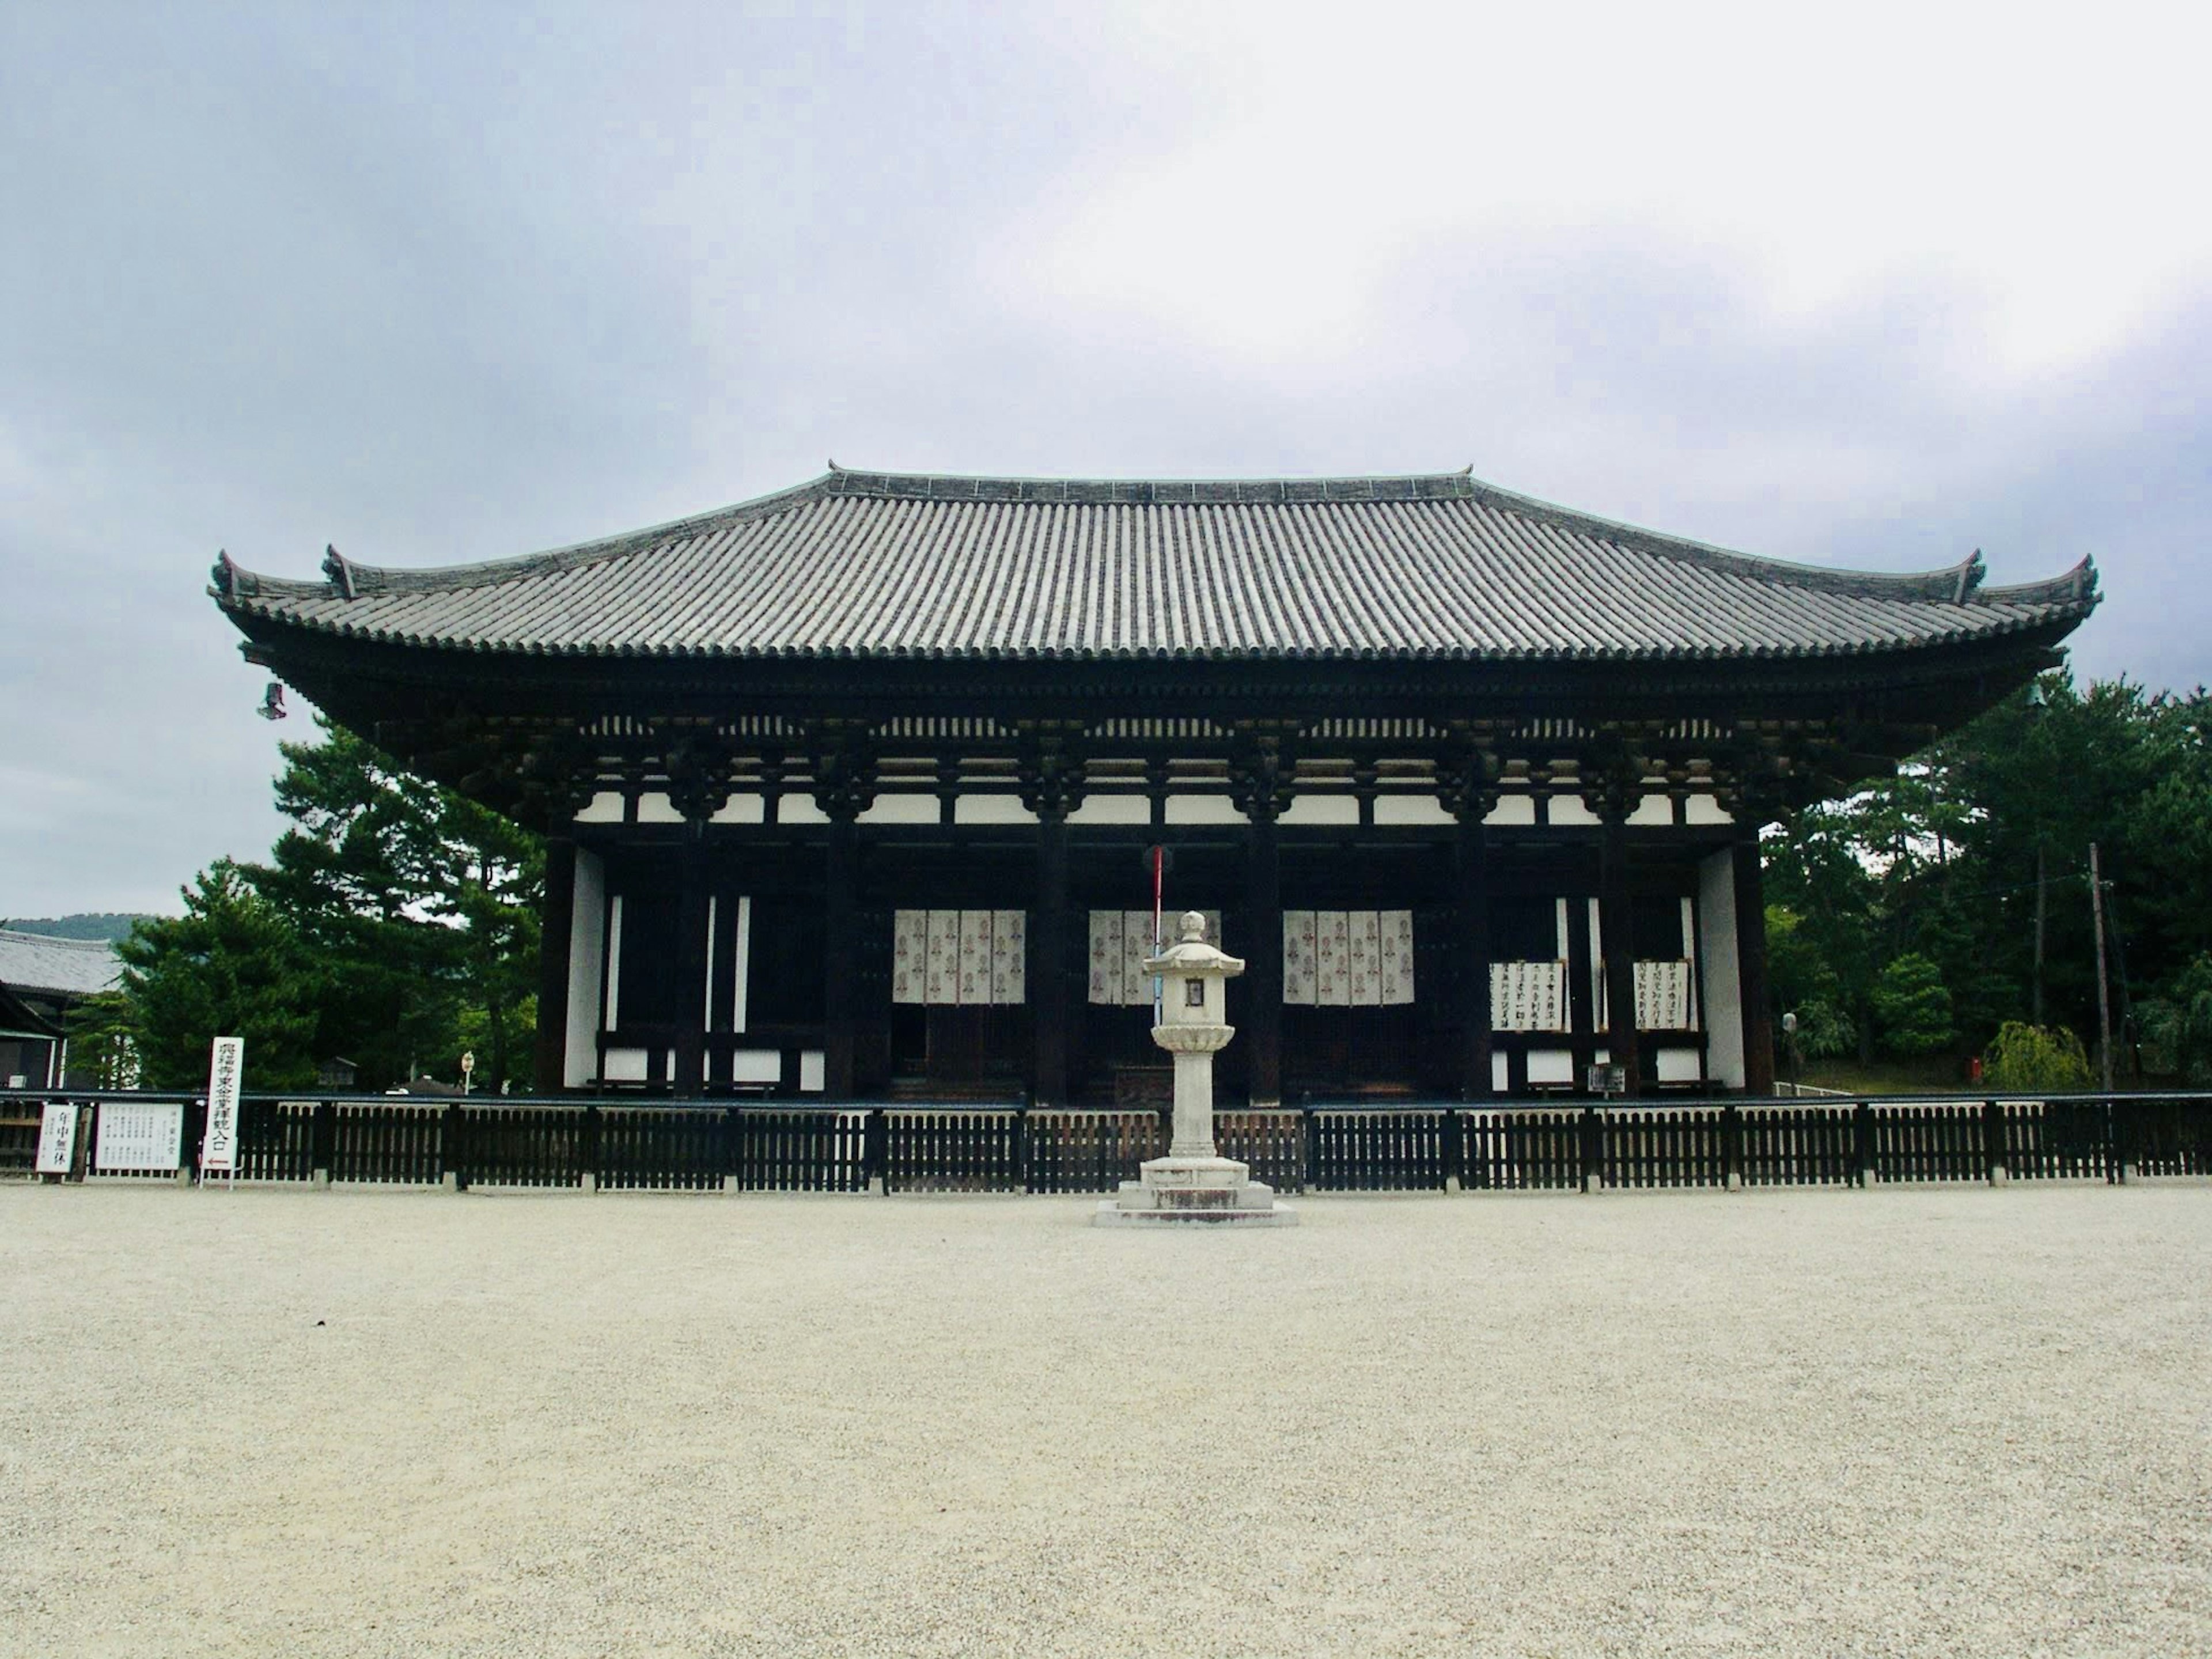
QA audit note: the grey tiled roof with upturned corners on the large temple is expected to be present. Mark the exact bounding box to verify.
[214,467,2097,659]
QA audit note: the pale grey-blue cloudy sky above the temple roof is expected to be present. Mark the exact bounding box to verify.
[0,0,2212,916]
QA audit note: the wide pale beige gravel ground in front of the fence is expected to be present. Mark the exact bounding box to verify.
[0,1185,2212,1659]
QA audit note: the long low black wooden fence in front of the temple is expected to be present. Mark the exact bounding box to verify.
[0,1090,2212,1192]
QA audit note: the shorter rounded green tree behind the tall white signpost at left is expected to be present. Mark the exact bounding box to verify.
[108,858,316,1088]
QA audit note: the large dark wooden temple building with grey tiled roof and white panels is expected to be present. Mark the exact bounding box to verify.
[213,467,2097,1106]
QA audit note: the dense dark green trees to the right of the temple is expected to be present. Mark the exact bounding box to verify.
[1765,671,2212,1079]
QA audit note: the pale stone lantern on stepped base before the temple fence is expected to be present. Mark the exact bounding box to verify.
[1093,909,1298,1228]
